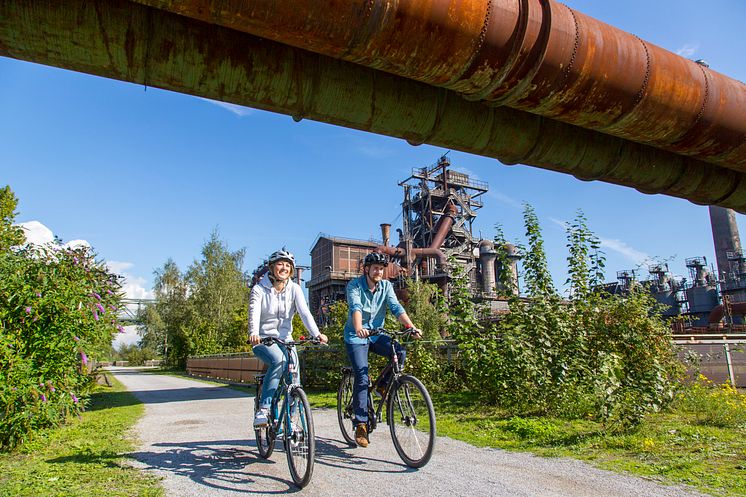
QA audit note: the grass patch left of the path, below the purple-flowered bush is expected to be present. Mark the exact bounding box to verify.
[0,377,163,497]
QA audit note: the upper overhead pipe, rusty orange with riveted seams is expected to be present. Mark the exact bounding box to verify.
[137,0,746,171]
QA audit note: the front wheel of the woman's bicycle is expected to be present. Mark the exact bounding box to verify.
[285,387,316,488]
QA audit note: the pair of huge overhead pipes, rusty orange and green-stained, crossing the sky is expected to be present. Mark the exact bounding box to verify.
[0,0,746,208]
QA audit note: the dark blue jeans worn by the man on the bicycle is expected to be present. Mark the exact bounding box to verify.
[345,335,407,424]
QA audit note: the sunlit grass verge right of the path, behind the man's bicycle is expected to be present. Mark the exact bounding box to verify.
[309,392,746,496]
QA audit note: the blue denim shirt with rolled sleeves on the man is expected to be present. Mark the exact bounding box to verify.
[345,275,404,343]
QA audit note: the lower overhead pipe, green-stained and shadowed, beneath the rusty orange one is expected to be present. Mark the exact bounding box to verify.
[0,0,746,212]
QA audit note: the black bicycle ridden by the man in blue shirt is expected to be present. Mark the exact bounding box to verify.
[337,328,435,468]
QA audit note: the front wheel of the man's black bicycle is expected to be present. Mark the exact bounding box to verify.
[387,375,435,468]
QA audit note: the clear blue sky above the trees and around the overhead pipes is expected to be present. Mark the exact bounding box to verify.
[0,0,746,314]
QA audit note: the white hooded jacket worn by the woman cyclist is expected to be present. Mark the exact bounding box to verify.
[249,274,320,340]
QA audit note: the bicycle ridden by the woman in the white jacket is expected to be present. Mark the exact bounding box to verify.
[254,337,320,488]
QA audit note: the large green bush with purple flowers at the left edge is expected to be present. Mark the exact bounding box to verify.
[0,247,121,449]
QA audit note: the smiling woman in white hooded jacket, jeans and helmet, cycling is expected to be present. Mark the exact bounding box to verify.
[249,247,328,428]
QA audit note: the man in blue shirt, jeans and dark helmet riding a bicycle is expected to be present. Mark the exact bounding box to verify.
[344,252,421,447]
